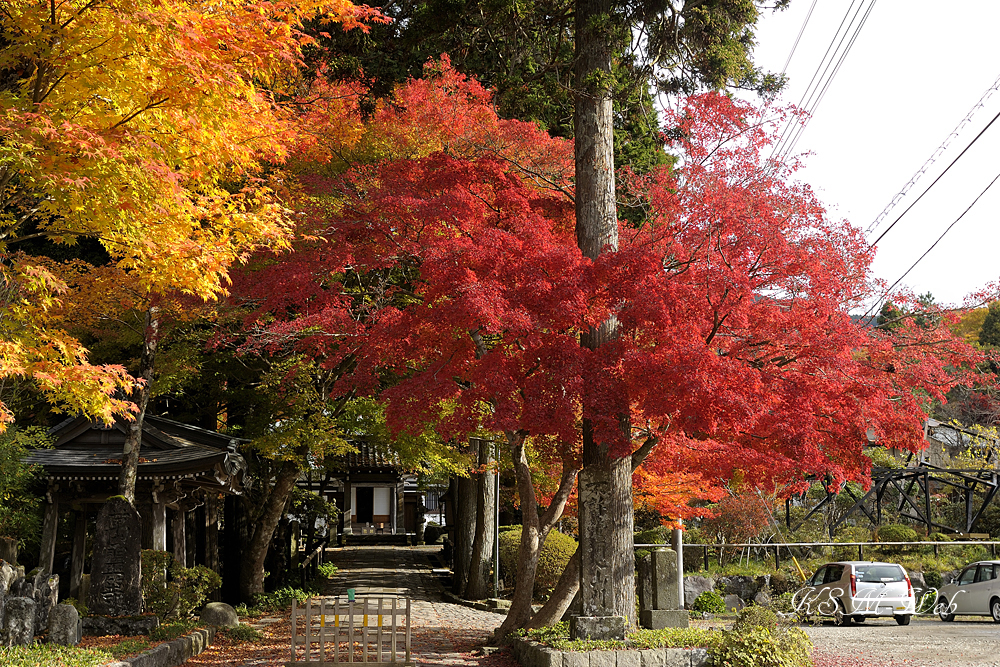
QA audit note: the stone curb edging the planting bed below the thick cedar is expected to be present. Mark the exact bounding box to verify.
[509,637,712,667]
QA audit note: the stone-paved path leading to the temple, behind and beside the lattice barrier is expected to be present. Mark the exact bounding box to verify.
[324,546,504,665]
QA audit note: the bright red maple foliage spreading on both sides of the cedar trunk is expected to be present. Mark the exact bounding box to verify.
[236,75,978,516]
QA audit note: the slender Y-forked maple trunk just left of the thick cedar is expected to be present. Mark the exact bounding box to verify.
[493,432,577,643]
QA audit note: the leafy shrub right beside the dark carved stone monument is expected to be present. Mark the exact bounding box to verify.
[140,549,222,618]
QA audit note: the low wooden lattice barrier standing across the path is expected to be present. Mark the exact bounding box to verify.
[285,597,414,667]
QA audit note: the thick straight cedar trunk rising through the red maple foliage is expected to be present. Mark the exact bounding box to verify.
[574,0,635,624]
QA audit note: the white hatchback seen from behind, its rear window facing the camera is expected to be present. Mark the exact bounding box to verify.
[793,561,916,625]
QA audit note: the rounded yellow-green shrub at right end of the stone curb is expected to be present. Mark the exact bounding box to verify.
[709,605,812,667]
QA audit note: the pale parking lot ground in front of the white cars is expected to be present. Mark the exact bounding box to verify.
[802,618,1000,667]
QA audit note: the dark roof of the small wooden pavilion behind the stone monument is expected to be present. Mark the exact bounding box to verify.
[25,415,246,493]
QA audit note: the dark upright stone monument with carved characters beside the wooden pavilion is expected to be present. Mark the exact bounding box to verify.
[88,496,142,616]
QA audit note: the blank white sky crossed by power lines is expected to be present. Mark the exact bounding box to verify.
[755,0,1000,304]
